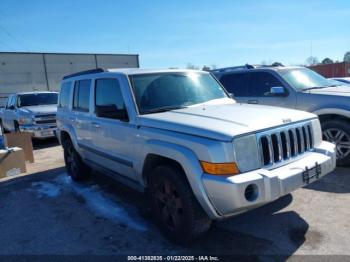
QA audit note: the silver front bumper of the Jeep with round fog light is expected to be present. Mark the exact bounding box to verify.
[202,142,336,218]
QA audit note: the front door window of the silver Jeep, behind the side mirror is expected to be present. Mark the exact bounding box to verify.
[95,79,125,110]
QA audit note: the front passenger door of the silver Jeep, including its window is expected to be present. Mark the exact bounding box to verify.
[91,78,137,179]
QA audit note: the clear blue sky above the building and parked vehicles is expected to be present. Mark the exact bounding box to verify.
[0,0,350,68]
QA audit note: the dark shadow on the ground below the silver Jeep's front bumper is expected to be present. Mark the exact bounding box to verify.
[185,195,309,257]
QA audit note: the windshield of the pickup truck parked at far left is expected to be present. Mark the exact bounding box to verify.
[17,93,58,107]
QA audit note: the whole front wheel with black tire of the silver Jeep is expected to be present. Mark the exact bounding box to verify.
[149,166,212,244]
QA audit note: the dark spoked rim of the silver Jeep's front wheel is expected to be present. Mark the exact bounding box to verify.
[155,180,183,230]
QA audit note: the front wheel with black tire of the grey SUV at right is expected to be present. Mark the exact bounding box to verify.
[321,120,350,166]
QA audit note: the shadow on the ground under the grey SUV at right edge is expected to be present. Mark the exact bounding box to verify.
[305,168,350,194]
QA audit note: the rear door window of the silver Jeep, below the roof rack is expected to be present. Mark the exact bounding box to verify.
[73,80,91,112]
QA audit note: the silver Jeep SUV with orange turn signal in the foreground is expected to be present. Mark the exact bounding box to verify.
[57,69,336,243]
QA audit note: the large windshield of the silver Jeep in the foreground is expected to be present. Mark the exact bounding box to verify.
[130,72,228,114]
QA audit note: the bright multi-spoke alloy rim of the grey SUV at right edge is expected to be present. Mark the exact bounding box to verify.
[322,128,350,159]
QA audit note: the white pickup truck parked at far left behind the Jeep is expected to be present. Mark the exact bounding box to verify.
[0,92,58,138]
